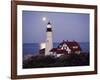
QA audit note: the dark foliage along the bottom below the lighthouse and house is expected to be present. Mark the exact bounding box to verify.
[23,53,89,68]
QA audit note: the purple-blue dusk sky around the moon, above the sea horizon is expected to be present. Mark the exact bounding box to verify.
[22,11,89,43]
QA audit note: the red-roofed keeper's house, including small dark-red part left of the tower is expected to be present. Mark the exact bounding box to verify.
[40,40,82,57]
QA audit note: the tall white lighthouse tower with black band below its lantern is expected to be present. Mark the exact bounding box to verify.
[45,22,53,55]
